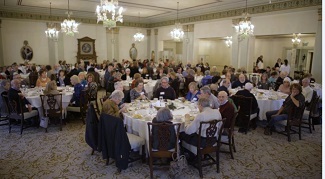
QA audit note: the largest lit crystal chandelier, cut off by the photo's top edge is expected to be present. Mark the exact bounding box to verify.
[96,0,123,29]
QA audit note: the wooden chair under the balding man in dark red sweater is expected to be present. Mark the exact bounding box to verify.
[220,112,238,159]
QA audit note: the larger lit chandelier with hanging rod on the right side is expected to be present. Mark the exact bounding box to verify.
[235,0,254,38]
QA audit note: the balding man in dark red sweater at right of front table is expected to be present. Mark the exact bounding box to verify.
[218,91,235,128]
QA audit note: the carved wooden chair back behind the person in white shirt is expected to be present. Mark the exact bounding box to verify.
[197,119,226,150]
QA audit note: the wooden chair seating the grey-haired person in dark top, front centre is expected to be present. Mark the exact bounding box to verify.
[147,122,181,178]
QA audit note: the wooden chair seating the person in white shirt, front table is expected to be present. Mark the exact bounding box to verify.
[182,119,225,178]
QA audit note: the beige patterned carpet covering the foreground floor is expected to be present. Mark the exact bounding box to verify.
[0,121,322,179]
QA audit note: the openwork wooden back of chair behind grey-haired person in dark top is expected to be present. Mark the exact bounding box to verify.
[147,122,181,153]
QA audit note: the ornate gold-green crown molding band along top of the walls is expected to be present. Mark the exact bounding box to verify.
[0,0,322,28]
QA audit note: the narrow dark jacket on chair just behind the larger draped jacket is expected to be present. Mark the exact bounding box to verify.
[85,103,99,150]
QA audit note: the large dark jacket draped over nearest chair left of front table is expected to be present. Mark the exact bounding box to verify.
[98,113,131,170]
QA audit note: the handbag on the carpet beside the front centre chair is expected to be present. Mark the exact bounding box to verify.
[169,147,188,178]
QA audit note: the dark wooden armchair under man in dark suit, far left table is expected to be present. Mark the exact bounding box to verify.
[2,95,39,135]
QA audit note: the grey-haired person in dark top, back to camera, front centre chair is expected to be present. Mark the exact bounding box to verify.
[152,108,176,150]
